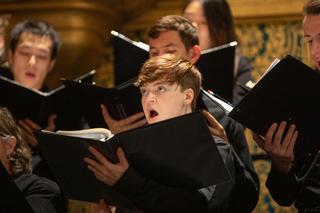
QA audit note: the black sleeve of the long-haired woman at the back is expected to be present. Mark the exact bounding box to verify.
[232,56,252,105]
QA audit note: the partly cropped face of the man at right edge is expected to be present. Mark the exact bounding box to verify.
[302,14,320,70]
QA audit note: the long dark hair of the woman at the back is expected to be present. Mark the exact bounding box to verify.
[183,0,237,48]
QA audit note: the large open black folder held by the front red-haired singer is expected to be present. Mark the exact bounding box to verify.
[34,111,231,208]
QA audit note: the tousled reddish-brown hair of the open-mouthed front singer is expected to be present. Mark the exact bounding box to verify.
[134,54,201,111]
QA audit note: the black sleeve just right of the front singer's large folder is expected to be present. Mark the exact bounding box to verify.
[226,119,260,212]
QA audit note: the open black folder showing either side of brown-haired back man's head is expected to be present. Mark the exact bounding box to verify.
[111,31,237,101]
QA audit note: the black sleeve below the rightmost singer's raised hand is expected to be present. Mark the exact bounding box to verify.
[266,165,300,206]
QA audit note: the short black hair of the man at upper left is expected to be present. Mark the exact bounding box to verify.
[10,20,61,60]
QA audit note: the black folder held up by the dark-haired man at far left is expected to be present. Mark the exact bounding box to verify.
[0,71,95,130]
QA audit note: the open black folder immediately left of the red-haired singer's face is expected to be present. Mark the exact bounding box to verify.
[63,78,143,128]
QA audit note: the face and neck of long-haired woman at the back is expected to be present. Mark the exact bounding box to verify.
[183,1,213,50]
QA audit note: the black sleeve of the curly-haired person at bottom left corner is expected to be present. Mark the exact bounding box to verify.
[15,174,67,213]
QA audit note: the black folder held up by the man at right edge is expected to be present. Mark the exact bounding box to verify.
[206,55,320,170]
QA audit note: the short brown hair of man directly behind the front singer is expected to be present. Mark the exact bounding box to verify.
[148,15,199,51]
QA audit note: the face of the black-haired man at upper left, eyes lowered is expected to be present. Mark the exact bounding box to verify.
[8,32,55,90]
